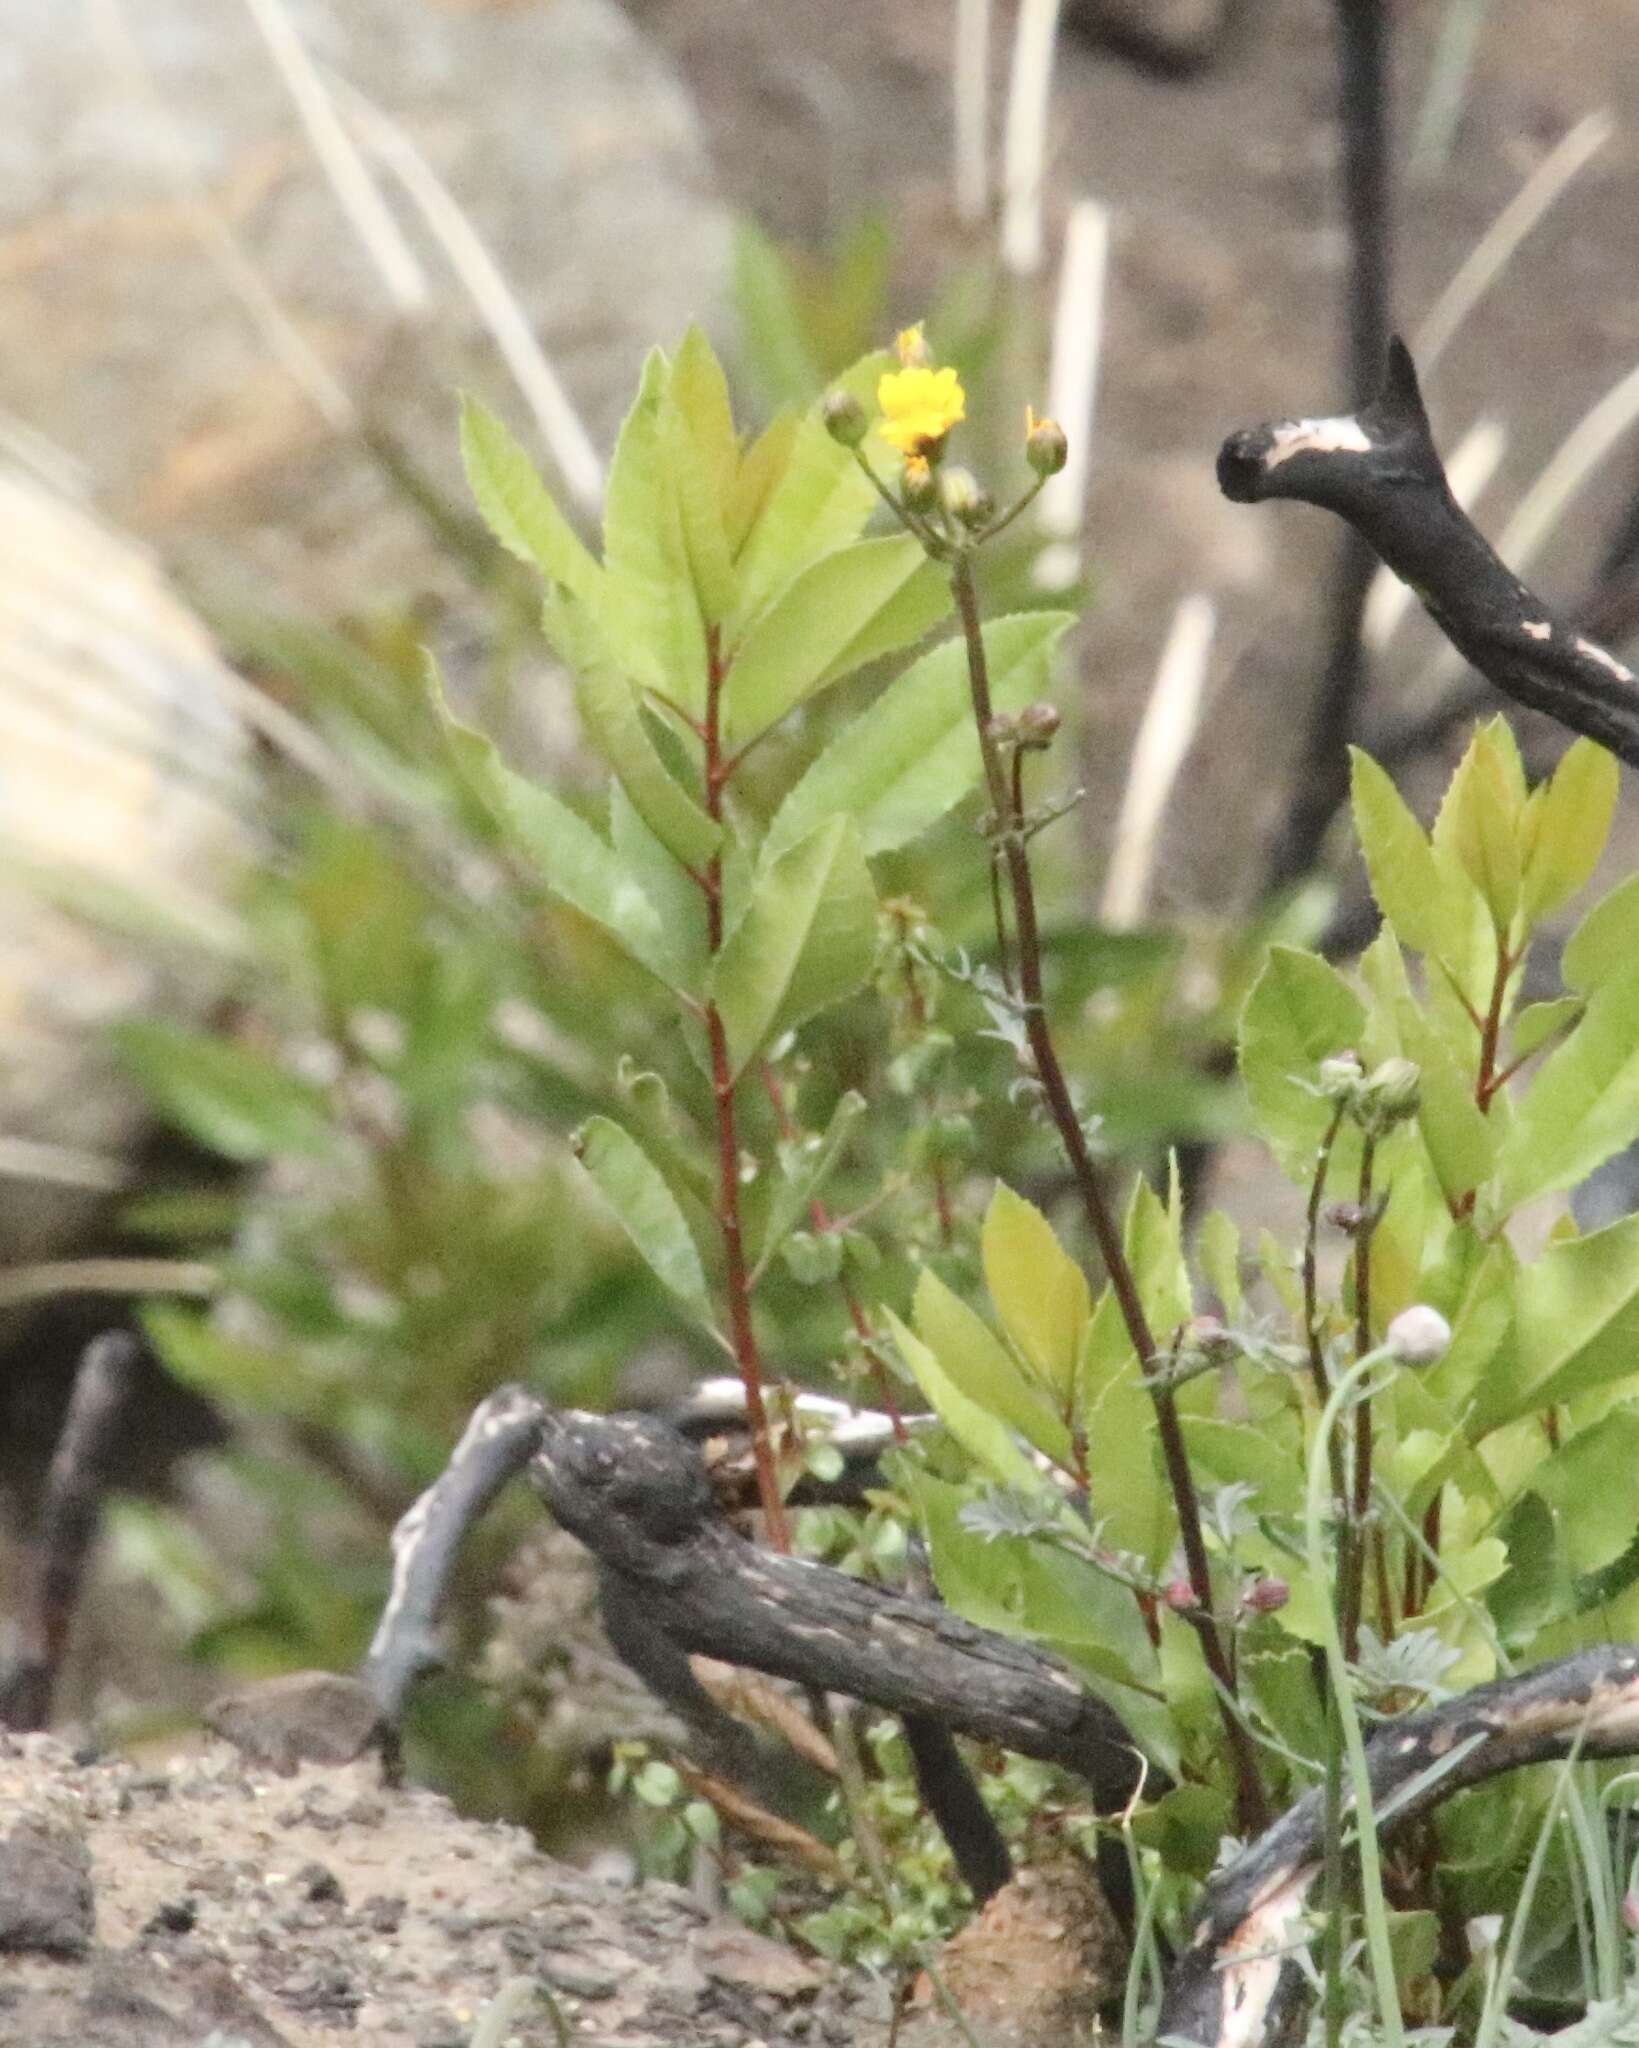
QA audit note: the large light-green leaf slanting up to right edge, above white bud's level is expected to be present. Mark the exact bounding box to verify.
[1498,958,1639,1214]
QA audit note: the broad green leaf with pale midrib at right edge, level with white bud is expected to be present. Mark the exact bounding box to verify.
[1485,1217,1639,1427]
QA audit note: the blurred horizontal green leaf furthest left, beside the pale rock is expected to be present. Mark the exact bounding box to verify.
[115,1018,334,1161]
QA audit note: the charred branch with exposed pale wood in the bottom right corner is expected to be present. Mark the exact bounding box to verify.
[1158,1642,1639,2048]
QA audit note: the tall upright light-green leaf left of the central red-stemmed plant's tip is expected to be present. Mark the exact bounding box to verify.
[600,348,707,713]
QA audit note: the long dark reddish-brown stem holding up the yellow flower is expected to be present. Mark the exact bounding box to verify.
[951,553,1268,1833]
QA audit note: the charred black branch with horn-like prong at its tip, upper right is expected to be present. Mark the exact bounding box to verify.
[1217,338,1639,768]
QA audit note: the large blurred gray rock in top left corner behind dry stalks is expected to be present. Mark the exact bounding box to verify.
[0,0,727,610]
